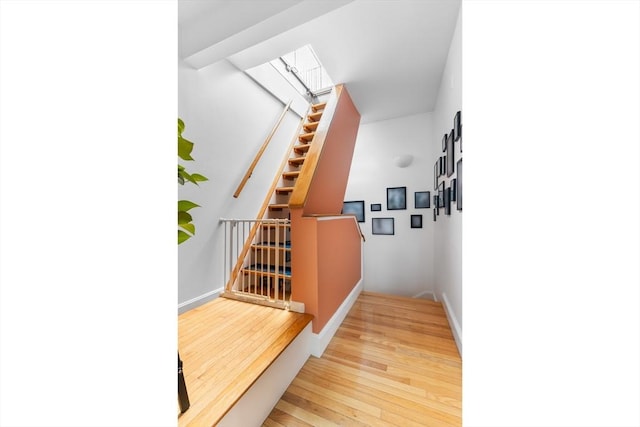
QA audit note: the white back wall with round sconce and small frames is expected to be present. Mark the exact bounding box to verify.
[345,114,434,297]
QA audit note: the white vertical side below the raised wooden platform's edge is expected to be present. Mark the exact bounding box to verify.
[218,323,312,427]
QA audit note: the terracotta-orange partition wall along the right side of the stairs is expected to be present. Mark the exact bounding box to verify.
[290,85,362,334]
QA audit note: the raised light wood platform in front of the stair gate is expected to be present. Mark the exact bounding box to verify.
[178,298,313,427]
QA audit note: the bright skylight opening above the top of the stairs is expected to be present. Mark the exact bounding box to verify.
[269,45,333,98]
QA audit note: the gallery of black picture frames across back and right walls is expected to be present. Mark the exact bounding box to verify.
[342,111,462,235]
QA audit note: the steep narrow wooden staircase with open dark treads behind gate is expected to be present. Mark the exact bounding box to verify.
[224,102,326,308]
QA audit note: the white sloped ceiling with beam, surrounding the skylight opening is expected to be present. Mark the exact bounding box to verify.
[178,0,460,123]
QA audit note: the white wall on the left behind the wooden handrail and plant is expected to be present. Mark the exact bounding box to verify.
[178,60,299,311]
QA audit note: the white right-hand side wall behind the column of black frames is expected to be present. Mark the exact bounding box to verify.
[429,9,460,353]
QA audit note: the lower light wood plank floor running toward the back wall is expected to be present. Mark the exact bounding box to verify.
[264,292,462,427]
